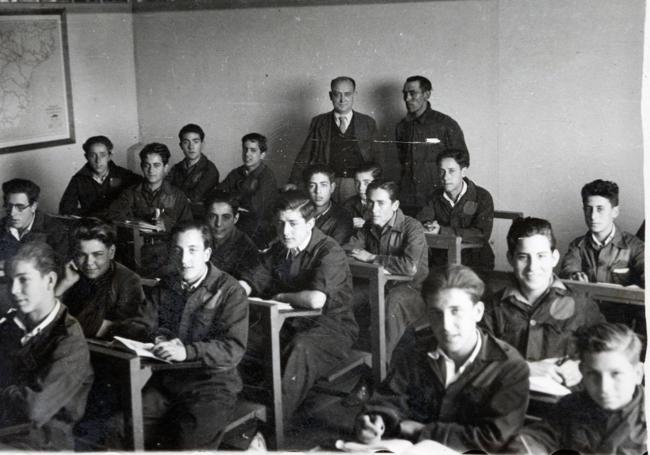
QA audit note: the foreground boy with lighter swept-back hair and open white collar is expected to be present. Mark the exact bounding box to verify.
[355,265,528,453]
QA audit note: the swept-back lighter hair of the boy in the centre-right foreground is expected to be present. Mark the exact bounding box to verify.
[422,264,485,306]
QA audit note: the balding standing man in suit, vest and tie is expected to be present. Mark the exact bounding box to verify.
[289,76,377,203]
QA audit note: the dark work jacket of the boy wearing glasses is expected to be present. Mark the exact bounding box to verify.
[0,209,68,261]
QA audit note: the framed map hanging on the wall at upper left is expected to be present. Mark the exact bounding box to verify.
[0,10,74,153]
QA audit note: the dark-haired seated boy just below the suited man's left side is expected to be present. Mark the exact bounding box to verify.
[302,164,354,245]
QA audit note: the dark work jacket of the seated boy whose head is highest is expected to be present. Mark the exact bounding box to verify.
[167,154,219,203]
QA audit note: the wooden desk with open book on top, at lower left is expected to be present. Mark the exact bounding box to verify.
[88,340,202,450]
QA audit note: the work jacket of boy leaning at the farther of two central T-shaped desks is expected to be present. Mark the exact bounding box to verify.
[344,209,429,289]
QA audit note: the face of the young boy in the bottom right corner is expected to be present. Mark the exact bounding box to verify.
[580,351,643,411]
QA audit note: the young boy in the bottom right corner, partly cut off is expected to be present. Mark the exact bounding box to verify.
[509,323,648,455]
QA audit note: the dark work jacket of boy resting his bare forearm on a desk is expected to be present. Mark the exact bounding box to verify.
[242,228,359,341]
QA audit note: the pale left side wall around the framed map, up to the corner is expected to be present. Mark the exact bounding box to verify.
[0,12,139,212]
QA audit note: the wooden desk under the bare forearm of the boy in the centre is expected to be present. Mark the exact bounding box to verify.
[249,300,321,450]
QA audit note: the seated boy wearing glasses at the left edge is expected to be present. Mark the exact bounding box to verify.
[0,179,67,263]
